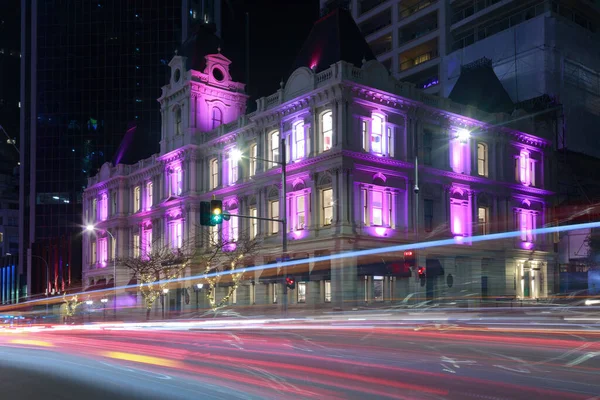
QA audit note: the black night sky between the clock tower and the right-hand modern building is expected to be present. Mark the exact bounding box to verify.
[222,0,319,104]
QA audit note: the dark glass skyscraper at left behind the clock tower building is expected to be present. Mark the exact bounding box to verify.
[19,0,220,297]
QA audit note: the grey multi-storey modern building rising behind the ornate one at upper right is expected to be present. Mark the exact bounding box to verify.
[332,0,600,156]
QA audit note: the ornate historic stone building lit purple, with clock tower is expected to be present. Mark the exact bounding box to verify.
[82,9,555,307]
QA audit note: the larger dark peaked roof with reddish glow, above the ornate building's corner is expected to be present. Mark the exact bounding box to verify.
[290,8,375,73]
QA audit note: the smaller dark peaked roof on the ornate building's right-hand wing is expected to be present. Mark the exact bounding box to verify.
[448,57,515,113]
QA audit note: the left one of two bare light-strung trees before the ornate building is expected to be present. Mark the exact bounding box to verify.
[117,238,196,318]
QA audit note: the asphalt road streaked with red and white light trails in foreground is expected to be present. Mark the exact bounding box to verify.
[0,318,600,400]
